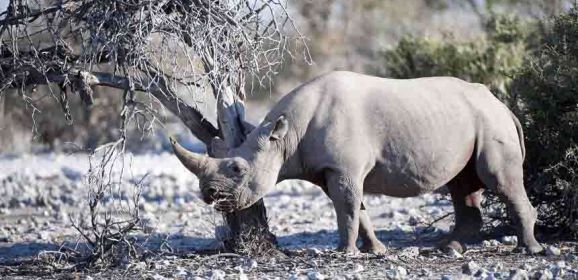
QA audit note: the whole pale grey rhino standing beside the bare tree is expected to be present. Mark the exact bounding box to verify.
[172,72,542,253]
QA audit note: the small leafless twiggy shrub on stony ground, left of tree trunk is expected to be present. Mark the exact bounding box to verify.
[71,141,144,264]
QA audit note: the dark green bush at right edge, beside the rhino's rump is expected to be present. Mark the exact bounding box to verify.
[512,7,578,237]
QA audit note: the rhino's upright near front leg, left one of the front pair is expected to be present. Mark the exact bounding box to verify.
[327,174,362,253]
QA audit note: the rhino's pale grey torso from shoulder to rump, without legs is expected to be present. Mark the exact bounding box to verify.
[274,72,515,196]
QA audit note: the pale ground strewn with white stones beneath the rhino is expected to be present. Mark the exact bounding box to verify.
[0,153,578,279]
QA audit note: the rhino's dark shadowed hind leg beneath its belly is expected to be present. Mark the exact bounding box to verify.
[442,163,483,253]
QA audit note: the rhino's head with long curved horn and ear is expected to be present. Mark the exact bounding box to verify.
[171,116,288,212]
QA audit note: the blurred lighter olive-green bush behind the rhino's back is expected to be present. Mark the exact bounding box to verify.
[378,13,528,103]
